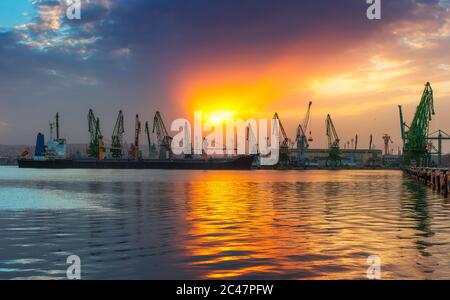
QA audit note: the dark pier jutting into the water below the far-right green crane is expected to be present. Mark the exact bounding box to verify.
[405,167,449,197]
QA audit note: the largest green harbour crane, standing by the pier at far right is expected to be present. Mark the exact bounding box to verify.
[399,82,435,166]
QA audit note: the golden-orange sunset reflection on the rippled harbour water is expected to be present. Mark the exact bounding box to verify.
[183,171,450,279]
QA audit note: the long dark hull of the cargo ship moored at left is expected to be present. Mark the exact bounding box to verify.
[18,155,254,170]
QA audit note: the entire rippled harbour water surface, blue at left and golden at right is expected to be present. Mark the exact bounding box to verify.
[0,167,450,279]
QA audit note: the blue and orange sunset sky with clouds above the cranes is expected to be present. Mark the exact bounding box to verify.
[0,0,450,151]
